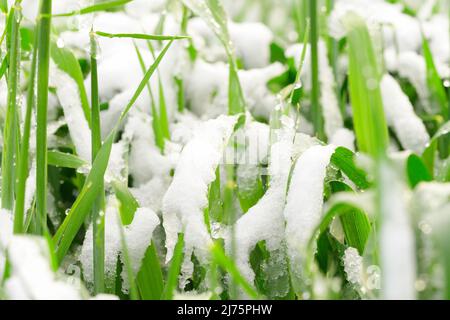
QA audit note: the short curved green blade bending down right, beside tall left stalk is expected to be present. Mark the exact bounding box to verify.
[51,42,91,127]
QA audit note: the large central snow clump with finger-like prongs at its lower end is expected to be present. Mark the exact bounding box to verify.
[163,116,237,278]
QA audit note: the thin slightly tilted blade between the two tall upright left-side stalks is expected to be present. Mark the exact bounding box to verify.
[14,28,37,233]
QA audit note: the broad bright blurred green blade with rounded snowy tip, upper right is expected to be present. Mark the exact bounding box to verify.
[344,13,389,157]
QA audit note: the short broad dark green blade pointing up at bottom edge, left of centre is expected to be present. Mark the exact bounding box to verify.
[136,242,164,300]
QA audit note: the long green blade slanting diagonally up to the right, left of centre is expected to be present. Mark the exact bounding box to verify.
[54,41,173,262]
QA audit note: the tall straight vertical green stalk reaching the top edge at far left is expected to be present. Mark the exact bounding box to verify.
[36,0,52,234]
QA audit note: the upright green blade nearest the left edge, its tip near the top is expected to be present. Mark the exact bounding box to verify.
[1,1,21,210]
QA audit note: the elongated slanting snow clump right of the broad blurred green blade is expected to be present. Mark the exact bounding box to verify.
[380,75,430,154]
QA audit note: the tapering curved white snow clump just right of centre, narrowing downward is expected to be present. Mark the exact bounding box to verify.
[284,146,335,272]
